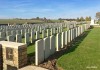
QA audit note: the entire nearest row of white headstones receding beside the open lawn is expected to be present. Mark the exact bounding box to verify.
[35,24,90,65]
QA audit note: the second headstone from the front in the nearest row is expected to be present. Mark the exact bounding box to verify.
[43,37,50,59]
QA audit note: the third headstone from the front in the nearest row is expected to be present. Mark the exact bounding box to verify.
[50,35,56,55]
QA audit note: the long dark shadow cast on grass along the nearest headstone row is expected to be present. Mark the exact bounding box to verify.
[44,29,91,62]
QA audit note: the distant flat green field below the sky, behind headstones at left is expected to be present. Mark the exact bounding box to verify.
[0,19,44,24]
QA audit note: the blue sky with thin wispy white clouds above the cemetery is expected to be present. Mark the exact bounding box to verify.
[0,0,100,18]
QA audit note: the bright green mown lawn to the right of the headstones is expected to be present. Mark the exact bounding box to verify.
[57,28,100,70]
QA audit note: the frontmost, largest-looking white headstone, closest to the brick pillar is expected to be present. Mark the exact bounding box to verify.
[35,39,44,65]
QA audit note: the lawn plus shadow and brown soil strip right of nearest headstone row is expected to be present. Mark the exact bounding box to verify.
[31,28,100,70]
